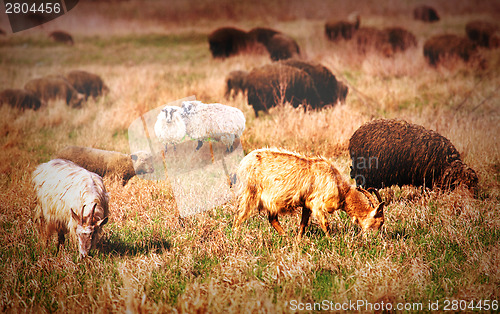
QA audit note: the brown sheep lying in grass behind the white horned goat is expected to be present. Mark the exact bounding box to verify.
[56,146,154,185]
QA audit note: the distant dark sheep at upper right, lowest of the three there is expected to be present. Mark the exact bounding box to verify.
[424,34,477,66]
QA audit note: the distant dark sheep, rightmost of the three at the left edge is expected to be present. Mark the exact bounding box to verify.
[66,70,109,100]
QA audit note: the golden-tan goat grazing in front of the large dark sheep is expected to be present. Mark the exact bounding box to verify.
[234,148,384,238]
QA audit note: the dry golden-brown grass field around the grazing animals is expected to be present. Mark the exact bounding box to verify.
[0,0,500,313]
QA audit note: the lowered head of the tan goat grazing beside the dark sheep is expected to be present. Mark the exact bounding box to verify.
[345,187,385,231]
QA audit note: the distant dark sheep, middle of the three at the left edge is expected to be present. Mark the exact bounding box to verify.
[24,75,85,108]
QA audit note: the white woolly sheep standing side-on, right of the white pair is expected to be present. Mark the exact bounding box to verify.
[182,100,246,151]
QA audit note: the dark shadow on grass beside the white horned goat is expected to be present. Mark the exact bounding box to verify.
[96,239,172,256]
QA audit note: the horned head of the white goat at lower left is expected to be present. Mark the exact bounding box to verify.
[71,203,108,258]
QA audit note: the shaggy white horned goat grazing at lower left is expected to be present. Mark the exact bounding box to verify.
[32,159,109,257]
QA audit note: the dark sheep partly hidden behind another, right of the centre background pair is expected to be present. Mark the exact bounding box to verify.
[281,59,345,105]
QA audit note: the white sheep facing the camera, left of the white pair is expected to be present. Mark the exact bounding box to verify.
[155,106,186,152]
